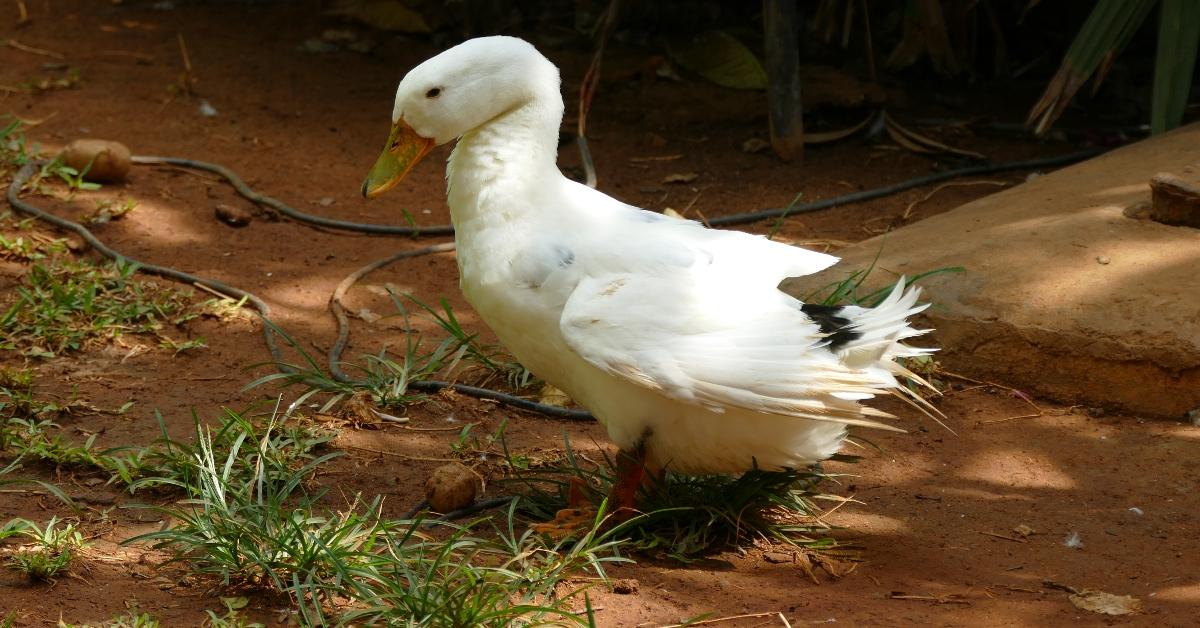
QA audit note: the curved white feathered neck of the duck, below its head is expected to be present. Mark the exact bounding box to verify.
[446,92,563,234]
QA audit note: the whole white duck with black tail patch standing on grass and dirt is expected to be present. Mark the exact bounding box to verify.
[362,37,928,523]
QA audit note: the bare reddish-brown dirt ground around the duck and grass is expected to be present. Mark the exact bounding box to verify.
[0,0,1200,627]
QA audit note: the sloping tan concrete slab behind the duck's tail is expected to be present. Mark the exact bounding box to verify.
[784,124,1200,418]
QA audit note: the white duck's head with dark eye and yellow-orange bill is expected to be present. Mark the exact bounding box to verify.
[362,36,562,198]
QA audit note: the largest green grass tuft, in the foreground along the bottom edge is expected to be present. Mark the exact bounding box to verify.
[126,405,622,626]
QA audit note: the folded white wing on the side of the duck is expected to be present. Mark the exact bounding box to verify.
[559,221,907,429]
